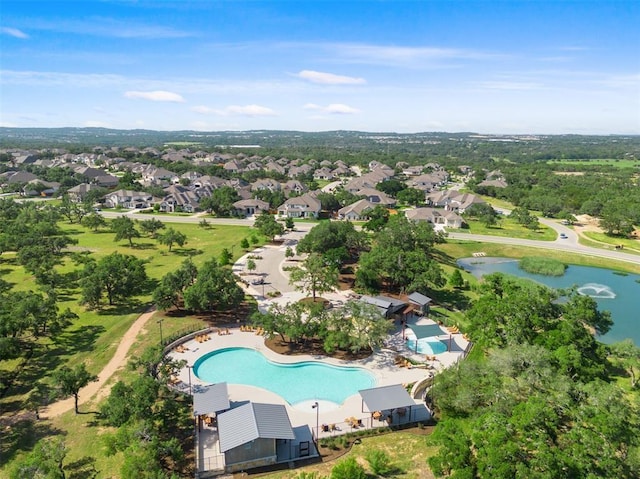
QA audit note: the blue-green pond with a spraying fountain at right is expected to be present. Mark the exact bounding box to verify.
[458,257,640,345]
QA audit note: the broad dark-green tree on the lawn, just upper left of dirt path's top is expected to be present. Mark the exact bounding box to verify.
[82,252,147,307]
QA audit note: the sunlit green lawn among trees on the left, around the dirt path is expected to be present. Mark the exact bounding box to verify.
[0,220,262,477]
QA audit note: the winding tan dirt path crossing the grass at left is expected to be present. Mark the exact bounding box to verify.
[40,308,156,418]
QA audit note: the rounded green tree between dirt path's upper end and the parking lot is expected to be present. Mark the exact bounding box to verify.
[184,260,244,311]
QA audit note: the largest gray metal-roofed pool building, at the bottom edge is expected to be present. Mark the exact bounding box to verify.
[217,402,296,473]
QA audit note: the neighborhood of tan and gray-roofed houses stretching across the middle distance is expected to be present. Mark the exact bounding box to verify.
[0,148,506,228]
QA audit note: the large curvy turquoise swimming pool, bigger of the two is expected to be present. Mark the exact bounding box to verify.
[193,348,376,406]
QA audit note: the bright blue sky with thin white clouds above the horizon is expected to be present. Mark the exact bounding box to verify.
[0,0,640,134]
